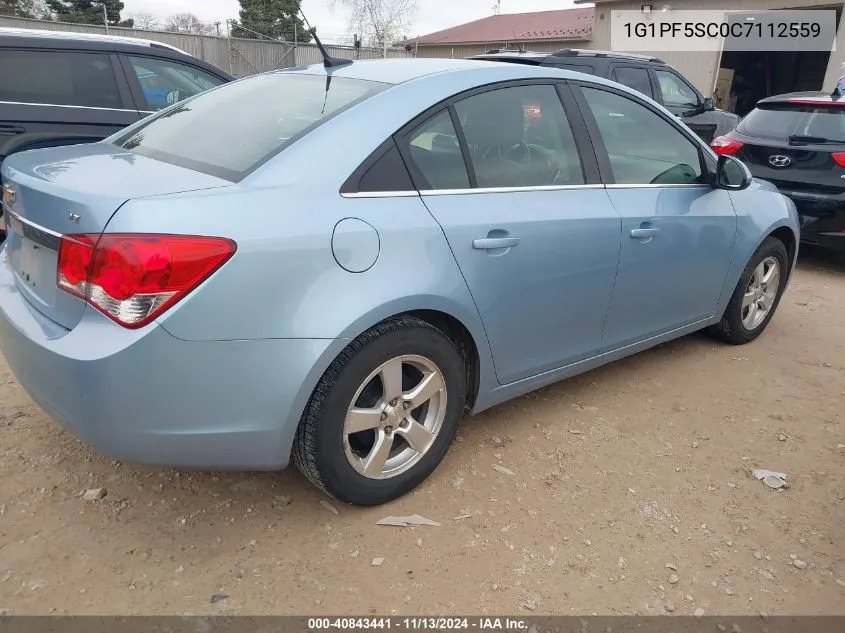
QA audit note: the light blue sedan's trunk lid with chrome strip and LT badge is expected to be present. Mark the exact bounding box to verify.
[2,143,231,329]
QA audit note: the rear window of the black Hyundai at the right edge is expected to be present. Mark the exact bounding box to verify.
[737,103,845,143]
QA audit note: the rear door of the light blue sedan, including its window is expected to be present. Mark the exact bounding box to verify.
[397,83,621,384]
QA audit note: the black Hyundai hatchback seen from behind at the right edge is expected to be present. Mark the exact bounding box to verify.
[711,92,845,251]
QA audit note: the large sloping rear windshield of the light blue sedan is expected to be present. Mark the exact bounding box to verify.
[109,73,389,182]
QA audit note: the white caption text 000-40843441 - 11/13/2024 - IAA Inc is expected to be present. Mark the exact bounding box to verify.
[307,617,529,631]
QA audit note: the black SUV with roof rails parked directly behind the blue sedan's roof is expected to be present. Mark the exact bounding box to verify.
[472,48,739,143]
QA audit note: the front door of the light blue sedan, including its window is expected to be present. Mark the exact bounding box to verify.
[575,84,737,349]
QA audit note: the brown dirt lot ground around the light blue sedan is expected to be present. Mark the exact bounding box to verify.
[0,253,845,615]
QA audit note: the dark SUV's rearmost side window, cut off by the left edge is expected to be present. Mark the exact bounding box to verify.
[0,50,123,109]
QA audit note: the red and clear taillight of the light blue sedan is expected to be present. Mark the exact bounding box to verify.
[56,233,237,328]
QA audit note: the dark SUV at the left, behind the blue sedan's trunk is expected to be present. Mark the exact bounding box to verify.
[0,29,233,170]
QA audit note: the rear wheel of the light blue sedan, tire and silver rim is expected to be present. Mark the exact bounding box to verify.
[293,316,467,506]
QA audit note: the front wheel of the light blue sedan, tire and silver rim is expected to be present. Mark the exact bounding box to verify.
[709,237,790,345]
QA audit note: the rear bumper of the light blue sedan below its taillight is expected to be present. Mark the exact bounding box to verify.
[0,256,338,470]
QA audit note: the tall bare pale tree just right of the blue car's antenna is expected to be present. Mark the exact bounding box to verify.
[329,0,418,47]
